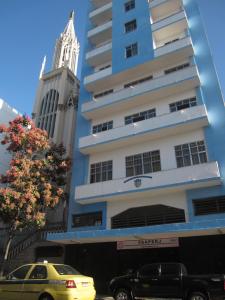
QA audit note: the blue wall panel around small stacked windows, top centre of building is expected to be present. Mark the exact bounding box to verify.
[112,0,154,74]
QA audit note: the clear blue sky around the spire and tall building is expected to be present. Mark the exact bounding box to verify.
[0,0,225,116]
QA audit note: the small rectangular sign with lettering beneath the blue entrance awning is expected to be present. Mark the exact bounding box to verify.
[117,238,179,250]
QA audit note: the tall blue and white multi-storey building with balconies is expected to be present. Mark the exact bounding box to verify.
[48,0,225,290]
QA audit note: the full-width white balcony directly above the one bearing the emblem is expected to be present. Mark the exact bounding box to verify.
[79,105,208,154]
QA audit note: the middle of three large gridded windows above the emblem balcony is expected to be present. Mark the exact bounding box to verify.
[126,150,161,177]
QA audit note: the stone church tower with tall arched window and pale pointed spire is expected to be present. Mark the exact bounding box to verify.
[32,11,79,155]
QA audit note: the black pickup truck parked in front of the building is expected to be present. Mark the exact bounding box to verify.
[109,263,225,300]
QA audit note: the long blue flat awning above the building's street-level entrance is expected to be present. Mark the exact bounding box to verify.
[47,219,225,244]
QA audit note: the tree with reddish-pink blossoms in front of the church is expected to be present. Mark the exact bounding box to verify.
[0,116,70,271]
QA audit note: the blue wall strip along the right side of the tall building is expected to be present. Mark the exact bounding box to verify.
[183,0,225,221]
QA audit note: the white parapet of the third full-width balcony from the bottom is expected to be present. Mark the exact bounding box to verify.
[82,66,198,113]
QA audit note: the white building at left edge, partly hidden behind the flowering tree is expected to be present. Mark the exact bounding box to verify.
[0,99,19,178]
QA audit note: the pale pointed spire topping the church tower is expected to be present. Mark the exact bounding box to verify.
[53,11,80,75]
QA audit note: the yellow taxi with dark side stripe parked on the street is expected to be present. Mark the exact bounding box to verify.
[0,262,96,300]
